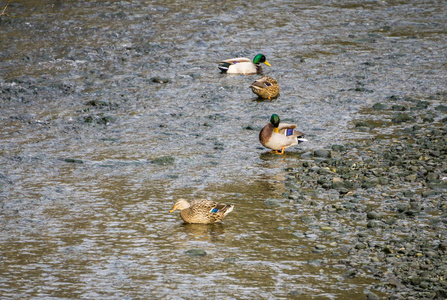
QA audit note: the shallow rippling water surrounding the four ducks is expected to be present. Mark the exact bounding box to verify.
[0,0,446,299]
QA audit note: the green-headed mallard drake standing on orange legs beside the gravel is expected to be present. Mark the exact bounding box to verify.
[259,114,307,154]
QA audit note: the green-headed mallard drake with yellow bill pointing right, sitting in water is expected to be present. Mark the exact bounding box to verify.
[218,54,271,75]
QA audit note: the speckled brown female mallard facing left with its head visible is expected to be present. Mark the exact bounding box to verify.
[169,199,234,224]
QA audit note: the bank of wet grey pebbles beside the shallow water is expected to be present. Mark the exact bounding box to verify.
[284,94,447,299]
